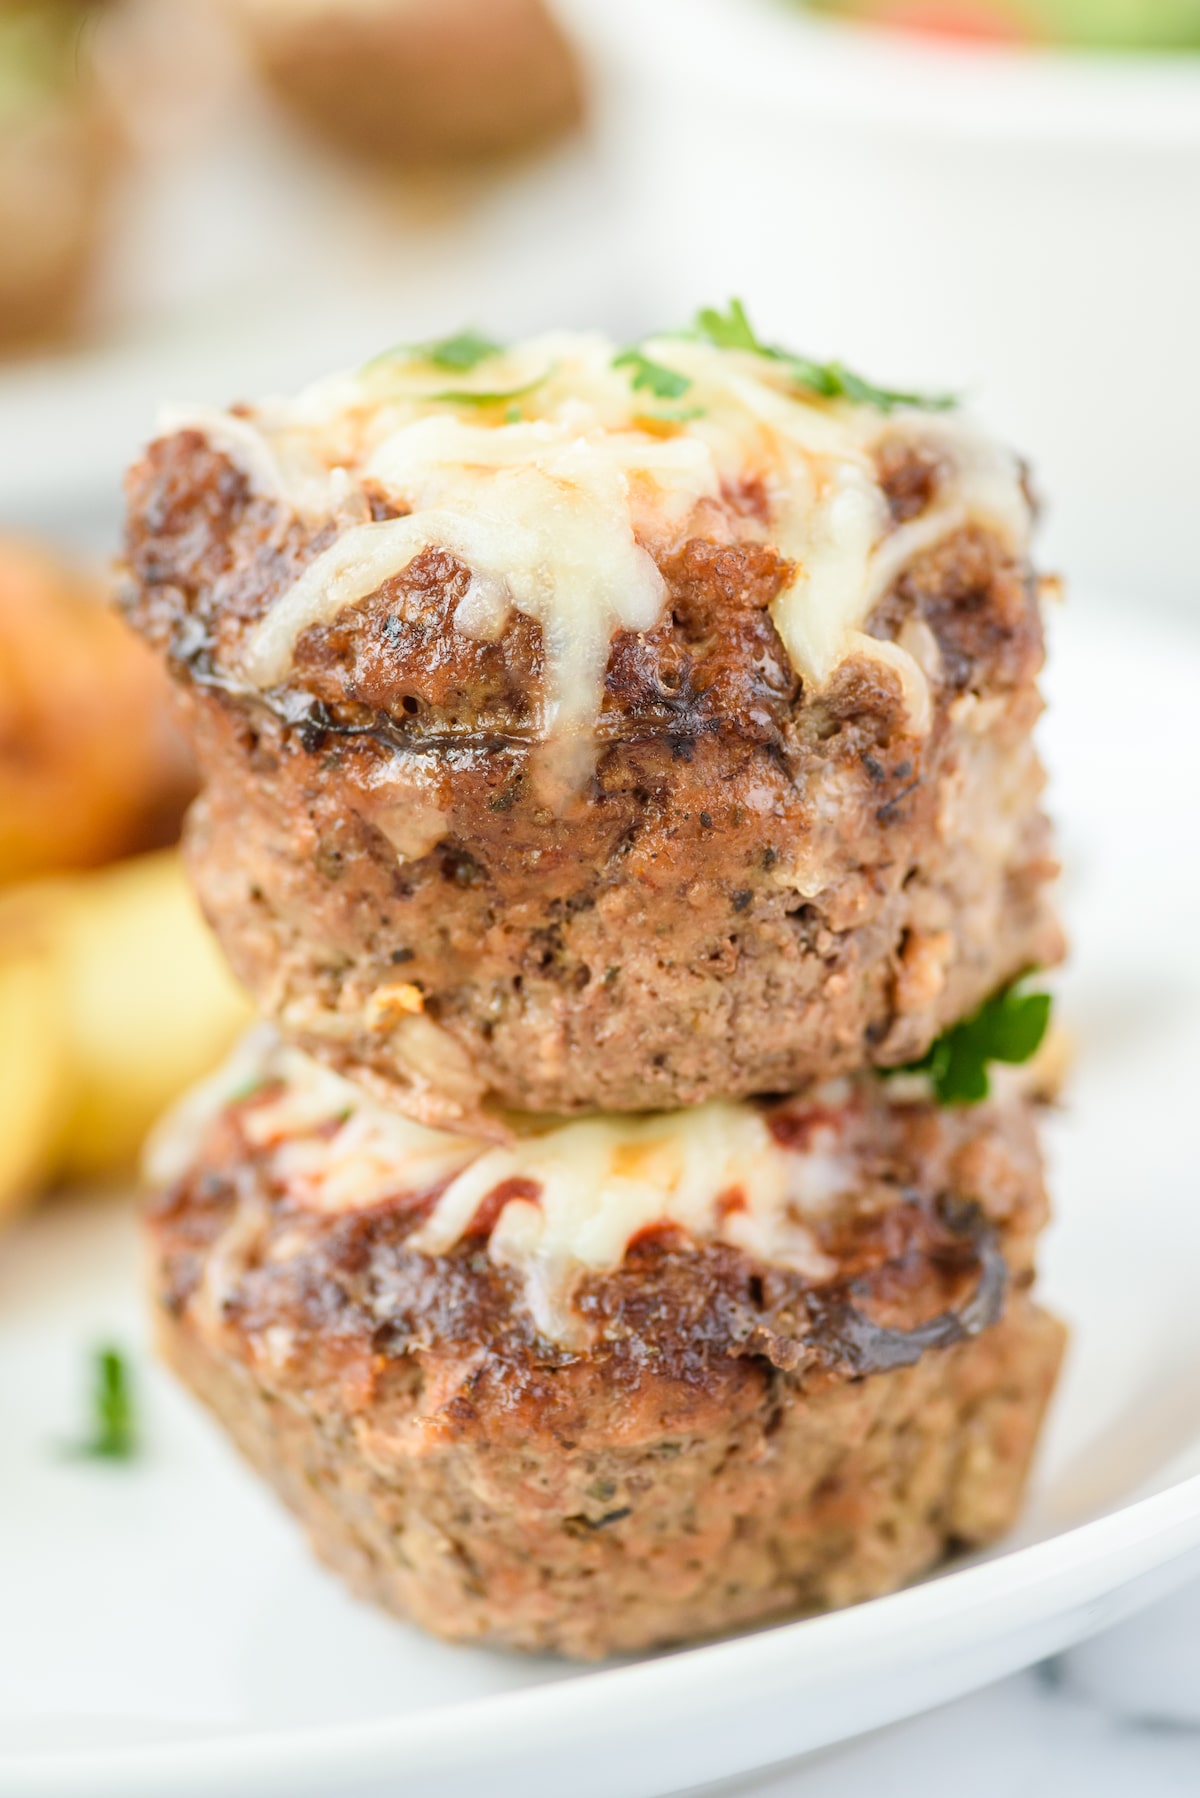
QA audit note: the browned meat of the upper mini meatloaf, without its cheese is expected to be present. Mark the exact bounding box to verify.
[119,433,1060,1124]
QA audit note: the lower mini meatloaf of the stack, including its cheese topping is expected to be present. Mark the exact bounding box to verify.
[148,1050,1063,1656]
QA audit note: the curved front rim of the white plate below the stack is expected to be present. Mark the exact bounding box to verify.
[14,1473,1200,1798]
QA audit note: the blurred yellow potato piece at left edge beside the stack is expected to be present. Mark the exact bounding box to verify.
[0,850,250,1214]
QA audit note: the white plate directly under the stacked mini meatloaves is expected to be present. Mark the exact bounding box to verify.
[0,602,1200,1798]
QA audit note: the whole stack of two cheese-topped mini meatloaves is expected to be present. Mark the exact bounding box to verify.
[126,323,1061,1656]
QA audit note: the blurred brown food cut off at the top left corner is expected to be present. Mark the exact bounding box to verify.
[0,0,121,345]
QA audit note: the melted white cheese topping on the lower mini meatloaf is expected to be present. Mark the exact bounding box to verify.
[148,1030,862,1343]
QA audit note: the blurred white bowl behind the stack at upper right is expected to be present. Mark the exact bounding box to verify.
[569,0,1200,608]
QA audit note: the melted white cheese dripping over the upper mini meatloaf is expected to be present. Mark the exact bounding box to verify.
[171,334,1029,762]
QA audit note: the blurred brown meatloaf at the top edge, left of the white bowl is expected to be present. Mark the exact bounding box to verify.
[227,0,581,165]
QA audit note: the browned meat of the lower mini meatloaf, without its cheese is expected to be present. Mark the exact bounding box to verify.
[148,1078,1063,1656]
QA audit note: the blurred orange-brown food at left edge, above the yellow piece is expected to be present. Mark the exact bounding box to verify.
[0,538,194,883]
